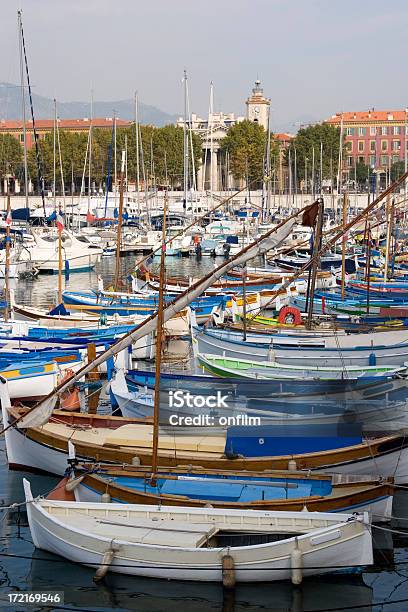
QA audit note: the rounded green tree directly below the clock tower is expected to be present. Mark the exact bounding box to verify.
[221,120,277,184]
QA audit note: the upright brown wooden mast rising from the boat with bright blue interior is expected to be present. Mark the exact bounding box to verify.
[151,191,167,484]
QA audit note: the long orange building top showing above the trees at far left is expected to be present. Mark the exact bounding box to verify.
[0,117,131,149]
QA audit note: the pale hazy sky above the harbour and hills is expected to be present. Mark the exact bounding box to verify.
[0,0,408,131]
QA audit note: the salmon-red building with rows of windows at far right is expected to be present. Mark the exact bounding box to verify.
[326,109,408,172]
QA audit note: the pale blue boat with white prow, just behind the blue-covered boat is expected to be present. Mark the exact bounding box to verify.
[110,370,408,434]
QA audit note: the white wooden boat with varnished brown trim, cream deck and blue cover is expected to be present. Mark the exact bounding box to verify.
[0,396,408,484]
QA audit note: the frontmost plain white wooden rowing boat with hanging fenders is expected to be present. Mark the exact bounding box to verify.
[24,479,373,582]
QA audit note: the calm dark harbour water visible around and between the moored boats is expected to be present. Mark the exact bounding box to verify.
[0,253,408,612]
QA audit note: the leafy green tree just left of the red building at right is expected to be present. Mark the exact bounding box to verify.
[286,123,340,180]
